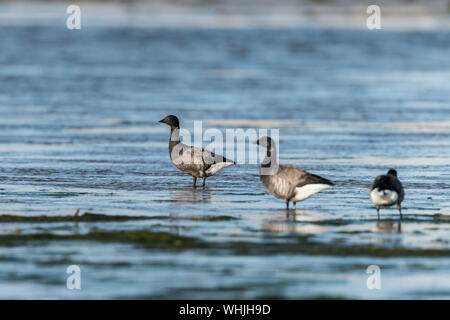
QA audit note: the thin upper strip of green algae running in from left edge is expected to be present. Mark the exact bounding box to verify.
[0,212,238,223]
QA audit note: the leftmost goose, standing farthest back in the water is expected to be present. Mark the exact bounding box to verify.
[159,115,235,188]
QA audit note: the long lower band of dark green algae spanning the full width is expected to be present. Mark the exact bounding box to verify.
[0,230,450,257]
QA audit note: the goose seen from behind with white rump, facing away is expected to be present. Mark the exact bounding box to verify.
[370,169,405,219]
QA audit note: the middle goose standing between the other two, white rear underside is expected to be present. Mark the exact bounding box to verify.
[255,137,334,210]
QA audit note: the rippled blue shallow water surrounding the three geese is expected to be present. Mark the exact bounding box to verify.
[0,27,450,299]
